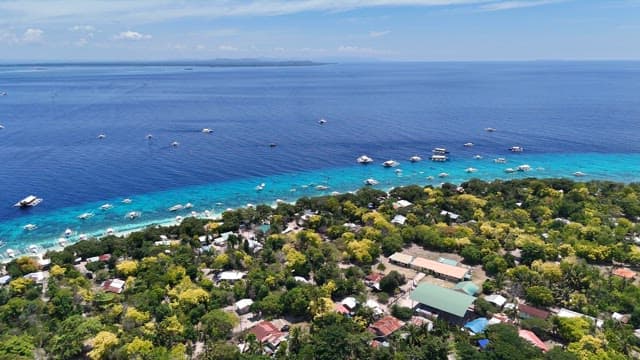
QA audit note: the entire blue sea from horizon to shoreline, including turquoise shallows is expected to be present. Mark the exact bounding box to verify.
[0,61,640,259]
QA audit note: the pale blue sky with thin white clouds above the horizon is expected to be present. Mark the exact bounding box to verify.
[0,0,640,62]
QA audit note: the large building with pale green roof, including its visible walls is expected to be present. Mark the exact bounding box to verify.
[409,284,476,324]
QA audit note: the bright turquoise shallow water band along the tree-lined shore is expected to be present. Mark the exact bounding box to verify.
[0,149,640,257]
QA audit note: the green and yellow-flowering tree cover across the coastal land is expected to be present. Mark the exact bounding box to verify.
[0,179,640,359]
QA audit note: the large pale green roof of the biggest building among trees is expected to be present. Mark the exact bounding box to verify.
[410,284,476,317]
